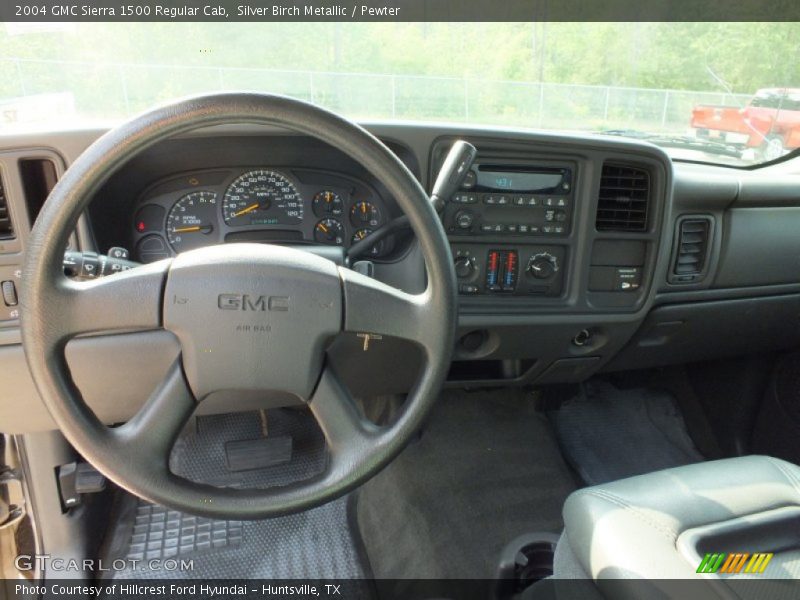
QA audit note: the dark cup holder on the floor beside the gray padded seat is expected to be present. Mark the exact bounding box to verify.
[495,532,560,600]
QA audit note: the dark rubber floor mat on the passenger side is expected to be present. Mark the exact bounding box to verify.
[550,381,704,485]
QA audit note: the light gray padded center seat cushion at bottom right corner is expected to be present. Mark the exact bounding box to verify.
[556,456,800,589]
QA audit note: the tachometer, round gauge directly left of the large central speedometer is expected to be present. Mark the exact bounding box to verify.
[167,192,217,253]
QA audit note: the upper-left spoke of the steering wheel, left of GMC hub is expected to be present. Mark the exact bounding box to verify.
[52,260,170,339]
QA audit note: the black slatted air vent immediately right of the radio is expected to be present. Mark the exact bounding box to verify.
[595,164,650,231]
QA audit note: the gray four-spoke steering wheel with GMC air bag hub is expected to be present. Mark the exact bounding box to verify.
[21,94,456,519]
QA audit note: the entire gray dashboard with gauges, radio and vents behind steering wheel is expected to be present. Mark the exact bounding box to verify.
[0,123,800,430]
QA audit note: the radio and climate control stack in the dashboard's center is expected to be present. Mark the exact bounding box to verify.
[443,159,576,297]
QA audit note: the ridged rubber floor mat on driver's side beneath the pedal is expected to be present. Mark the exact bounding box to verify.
[108,409,369,584]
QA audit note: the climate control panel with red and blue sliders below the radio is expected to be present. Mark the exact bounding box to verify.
[452,244,566,297]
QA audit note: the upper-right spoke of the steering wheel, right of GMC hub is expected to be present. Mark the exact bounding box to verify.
[339,269,436,349]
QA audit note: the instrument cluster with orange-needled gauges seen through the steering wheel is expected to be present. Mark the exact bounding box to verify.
[132,167,394,263]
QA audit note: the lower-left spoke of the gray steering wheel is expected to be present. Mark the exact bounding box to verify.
[111,358,197,466]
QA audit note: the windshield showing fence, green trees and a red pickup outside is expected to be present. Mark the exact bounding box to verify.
[0,22,800,165]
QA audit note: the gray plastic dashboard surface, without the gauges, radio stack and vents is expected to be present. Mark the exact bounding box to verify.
[0,123,800,432]
